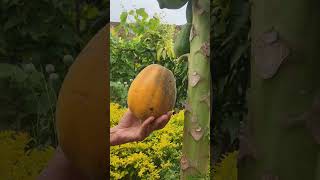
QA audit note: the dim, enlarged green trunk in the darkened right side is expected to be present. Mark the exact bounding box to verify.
[238,0,320,180]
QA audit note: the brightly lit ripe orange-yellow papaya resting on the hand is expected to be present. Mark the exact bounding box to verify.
[128,64,177,121]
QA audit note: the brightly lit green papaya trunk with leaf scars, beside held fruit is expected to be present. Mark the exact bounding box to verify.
[181,0,211,179]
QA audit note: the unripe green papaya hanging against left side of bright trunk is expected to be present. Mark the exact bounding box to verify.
[174,23,192,57]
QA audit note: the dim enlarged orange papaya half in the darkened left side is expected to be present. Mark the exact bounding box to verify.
[56,24,109,179]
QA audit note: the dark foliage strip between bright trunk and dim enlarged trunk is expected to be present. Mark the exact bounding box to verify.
[211,0,250,164]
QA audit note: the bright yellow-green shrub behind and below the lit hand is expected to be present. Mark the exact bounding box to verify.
[110,103,184,179]
